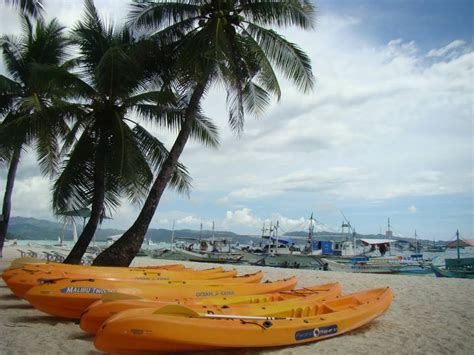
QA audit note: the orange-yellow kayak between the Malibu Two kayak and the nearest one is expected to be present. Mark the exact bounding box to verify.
[80,282,341,333]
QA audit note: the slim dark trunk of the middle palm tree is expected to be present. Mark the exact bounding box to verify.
[64,159,105,264]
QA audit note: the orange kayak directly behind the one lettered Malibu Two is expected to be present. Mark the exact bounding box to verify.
[6,269,243,298]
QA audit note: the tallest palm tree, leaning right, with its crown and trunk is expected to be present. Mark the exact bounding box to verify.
[94,0,314,265]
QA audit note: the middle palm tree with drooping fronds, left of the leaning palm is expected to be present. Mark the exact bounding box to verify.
[44,0,217,263]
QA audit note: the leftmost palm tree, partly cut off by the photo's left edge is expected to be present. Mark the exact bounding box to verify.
[0,16,68,252]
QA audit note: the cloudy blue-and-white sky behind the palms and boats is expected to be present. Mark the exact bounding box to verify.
[0,0,474,240]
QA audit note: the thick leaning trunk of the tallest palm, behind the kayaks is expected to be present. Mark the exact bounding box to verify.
[93,80,207,266]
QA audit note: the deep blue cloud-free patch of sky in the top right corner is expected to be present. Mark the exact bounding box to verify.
[315,0,474,50]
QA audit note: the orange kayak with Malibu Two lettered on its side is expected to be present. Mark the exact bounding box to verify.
[25,277,298,319]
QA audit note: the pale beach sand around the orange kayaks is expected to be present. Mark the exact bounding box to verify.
[0,247,474,354]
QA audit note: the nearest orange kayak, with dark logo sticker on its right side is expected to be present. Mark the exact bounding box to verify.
[94,288,393,352]
